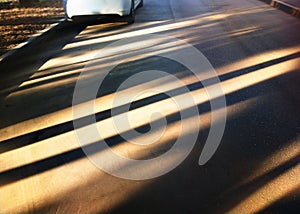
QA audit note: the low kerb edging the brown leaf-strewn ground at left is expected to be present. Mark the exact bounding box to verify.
[0,19,69,63]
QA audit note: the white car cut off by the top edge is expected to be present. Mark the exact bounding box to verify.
[63,0,143,24]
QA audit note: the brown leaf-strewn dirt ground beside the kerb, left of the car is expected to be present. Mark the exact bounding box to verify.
[0,0,64,55]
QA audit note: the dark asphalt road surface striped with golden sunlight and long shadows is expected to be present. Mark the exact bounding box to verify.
[0,0,300,213]
